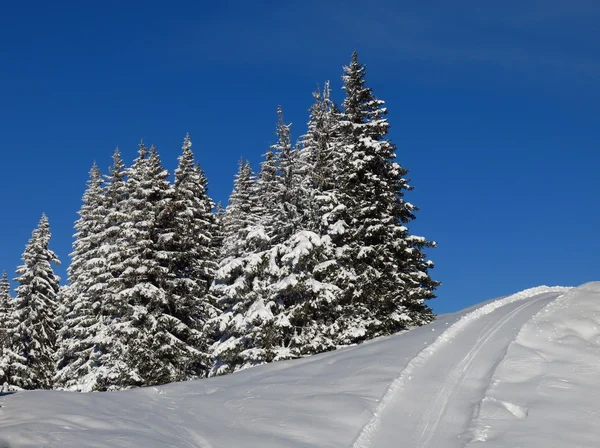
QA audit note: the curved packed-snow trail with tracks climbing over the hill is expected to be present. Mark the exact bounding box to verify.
[353,287,566,448]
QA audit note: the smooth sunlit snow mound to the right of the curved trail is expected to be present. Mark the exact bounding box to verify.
[468,283,600,448]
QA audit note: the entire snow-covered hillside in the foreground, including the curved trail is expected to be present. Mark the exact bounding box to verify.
[0,283,600,448]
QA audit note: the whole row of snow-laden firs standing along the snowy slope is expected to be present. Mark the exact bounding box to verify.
[0,53,439,391]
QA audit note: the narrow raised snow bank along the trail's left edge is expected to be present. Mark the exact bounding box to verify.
[352,286,572,448]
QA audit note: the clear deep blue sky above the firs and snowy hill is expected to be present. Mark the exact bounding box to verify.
[0,0,600,312]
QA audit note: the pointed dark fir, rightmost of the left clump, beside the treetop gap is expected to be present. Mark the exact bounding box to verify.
[154,135,219,381]
